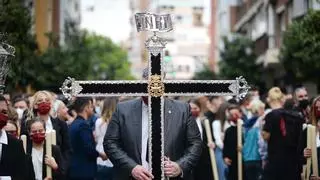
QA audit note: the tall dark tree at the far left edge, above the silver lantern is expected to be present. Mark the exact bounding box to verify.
[0,0,38,91]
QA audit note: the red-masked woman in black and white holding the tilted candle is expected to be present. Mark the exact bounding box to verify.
[189,99,215,180]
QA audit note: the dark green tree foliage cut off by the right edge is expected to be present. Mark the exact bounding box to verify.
[280,11,320,84]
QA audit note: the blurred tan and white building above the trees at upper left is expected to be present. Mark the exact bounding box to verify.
[25,0,81,52]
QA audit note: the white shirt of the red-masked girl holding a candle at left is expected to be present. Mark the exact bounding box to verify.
[31,148,43,180]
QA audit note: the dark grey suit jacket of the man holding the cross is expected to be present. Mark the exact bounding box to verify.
[103,99,202,180]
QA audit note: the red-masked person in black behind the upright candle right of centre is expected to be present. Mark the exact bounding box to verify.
[223,105,242,180]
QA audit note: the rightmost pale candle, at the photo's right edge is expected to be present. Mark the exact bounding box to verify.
[310,126,319,177]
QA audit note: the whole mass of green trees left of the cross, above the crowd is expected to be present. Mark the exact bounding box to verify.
[0,0,133,92]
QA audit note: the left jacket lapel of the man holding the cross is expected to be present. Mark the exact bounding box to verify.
[130,99,142,157]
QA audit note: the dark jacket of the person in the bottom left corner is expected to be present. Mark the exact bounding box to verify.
[0,131,26,180]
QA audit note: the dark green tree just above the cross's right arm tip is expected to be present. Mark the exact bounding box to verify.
[219,36,262,84]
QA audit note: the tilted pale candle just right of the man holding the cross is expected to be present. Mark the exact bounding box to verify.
[204,119,219,180]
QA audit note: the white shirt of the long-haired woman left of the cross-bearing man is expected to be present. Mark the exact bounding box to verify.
[95,118,113,167]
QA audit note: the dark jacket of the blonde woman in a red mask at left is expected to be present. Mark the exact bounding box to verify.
[21,117,72,168]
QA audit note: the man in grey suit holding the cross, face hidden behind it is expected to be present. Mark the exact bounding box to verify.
[104,70,201,180]
